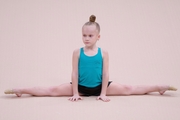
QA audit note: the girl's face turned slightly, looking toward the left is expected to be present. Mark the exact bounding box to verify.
[82,25,100,47]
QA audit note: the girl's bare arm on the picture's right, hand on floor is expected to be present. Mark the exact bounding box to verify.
[98,50,110,102]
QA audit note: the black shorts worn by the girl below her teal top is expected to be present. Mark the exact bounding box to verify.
[71,81,112,96]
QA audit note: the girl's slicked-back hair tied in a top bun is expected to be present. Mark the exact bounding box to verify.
[83,15,100,33]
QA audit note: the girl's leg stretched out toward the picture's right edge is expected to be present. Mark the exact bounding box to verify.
[107,82,177,95]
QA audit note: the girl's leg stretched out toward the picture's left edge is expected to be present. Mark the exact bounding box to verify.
[5,83,73,97]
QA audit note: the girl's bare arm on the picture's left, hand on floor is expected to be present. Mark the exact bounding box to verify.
[69,49,82,101]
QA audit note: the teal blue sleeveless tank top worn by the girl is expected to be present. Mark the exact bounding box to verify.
[78,48,103,88]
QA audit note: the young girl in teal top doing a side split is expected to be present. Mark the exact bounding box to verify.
[5,15,177,102]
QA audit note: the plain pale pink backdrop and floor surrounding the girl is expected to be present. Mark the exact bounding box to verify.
[0,0,180,120]
